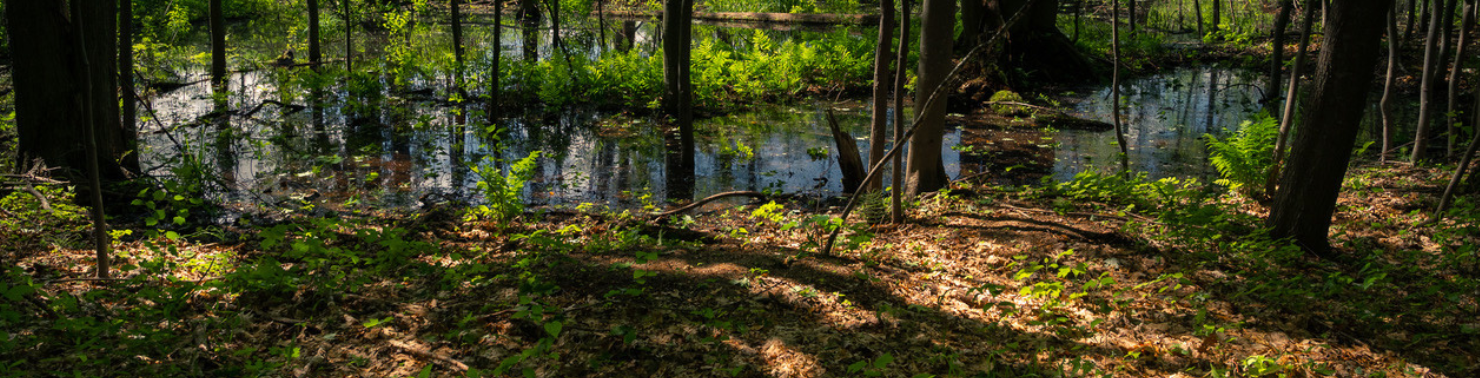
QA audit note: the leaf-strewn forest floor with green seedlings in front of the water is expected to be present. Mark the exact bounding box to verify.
[0,160,1480,377]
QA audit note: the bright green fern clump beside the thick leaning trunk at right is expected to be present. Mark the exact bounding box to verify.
[1208,114,1280,197]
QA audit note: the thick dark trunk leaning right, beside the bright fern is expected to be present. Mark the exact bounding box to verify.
[1268,0,1391,256]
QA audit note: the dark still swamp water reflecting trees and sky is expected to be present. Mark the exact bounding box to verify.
[141,13,1412,209]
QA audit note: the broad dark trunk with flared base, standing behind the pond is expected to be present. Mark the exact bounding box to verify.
[968,0,1098,86]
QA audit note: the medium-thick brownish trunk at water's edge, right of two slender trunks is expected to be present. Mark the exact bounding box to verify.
[904,0,953,196]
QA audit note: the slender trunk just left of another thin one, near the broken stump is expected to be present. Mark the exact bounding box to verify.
[863,0,893,191]
